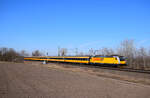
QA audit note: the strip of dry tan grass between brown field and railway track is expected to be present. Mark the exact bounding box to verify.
[25,62,150,85]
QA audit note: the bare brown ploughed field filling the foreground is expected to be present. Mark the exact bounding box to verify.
[0,62,150,98]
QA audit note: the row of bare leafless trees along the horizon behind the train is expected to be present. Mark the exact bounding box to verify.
[0,40,150,69]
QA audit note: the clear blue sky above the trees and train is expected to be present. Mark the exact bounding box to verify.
[0,0,150,55]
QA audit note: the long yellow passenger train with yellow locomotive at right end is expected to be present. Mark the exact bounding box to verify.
[24,55,127,67]
